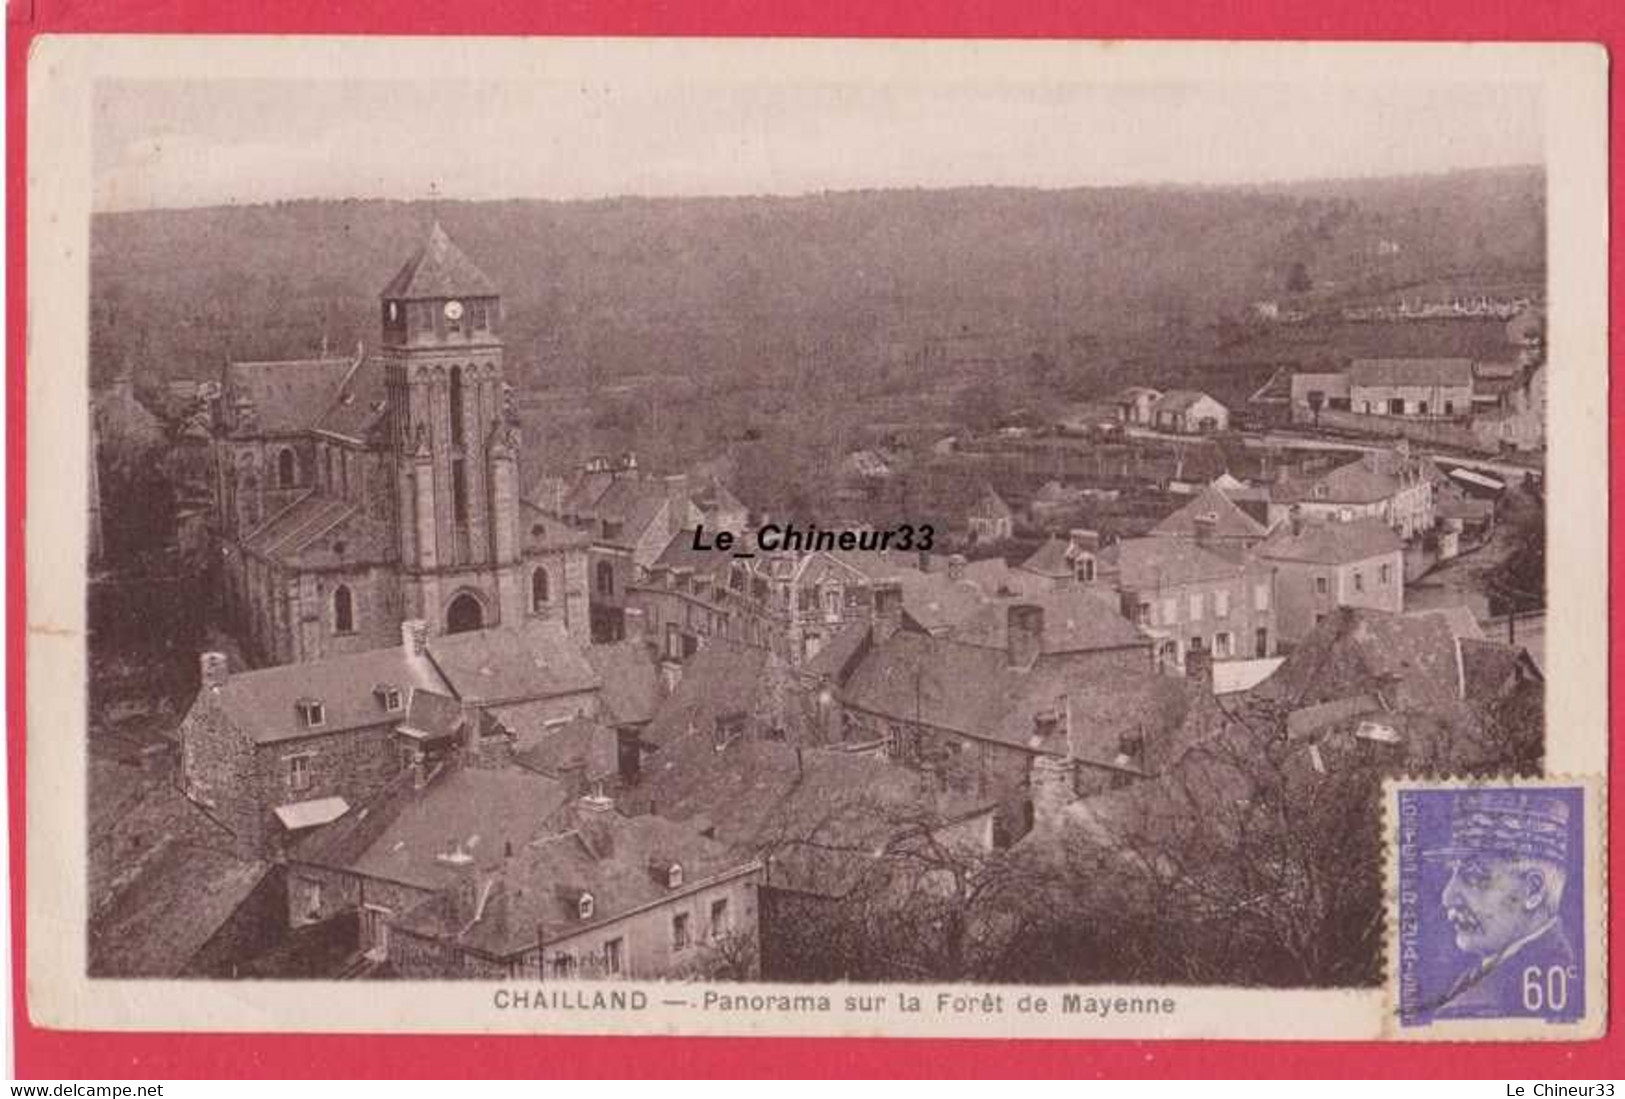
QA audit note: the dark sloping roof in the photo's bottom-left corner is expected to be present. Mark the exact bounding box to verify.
[88,841,270,977]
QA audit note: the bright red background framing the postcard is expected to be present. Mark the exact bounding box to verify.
[7,0,1625,1081]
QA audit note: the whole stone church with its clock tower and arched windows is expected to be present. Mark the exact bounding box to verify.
[213,223,590,665]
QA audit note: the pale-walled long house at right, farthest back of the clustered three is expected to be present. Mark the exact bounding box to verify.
[1268,447,1443,541]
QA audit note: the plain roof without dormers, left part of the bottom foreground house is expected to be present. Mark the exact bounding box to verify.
[291,764,570,889]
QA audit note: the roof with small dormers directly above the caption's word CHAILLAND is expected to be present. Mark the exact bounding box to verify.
[401,811,754,958]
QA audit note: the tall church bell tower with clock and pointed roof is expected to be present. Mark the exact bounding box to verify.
[380,223,522,632]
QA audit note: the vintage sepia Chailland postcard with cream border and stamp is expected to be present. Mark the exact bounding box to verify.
[26,36,1610,1040]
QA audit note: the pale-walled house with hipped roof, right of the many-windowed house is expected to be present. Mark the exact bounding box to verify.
[1255,517,1406,645]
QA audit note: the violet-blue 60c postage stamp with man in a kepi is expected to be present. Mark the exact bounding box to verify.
[1389,784,1597,1029]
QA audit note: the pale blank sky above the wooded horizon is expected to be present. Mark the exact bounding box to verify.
[91,78,1544,210]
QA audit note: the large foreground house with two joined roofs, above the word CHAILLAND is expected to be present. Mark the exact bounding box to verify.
[289,764,759,980]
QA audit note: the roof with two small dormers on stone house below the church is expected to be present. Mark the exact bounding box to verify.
[211,645,447,745]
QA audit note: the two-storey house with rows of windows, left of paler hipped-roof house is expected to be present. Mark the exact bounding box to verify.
[1099,536,1281,671]
